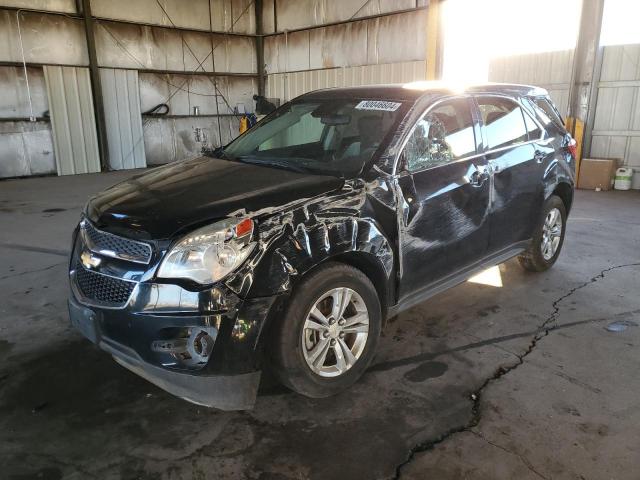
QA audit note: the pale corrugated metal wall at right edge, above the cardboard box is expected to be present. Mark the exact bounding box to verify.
[591,45,640,169]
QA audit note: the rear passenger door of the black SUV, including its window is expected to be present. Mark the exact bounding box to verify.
[476,95,544,253]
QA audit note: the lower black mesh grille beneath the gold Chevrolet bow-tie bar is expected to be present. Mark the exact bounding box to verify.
[76,262,136,307]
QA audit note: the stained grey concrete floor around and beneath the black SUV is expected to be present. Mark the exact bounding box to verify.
[0,172,640,480]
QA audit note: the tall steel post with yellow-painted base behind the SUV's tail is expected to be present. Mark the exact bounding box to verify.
[567,0,605,170]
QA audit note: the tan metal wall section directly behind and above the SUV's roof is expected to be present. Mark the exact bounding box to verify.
[263,0,428,102]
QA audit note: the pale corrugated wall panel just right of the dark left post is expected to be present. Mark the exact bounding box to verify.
[100,68,147,170]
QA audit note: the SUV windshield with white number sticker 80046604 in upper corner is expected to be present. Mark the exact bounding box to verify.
[215,99,405,177]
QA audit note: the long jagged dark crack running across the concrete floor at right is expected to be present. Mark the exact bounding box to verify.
[392,263,640,480]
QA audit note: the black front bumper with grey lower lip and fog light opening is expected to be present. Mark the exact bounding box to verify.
[69,286,275,410]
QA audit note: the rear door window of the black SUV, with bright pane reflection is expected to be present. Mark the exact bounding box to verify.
[478,97,528,149]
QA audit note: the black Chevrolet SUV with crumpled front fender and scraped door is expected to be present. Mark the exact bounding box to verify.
[69,83,575,409]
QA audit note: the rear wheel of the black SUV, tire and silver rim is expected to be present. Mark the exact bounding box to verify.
[518,195,567,272]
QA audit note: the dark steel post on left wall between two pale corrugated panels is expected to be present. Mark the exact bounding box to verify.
[76,0,109,172]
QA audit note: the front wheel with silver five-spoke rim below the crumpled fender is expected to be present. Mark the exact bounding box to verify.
[270,262,382,398]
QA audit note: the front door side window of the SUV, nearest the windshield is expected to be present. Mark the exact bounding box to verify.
[404,98,476,172]
